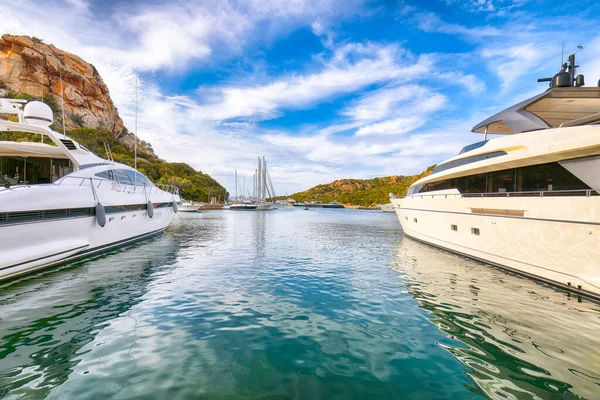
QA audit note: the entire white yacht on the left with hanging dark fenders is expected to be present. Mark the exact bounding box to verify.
[0,99,180,280]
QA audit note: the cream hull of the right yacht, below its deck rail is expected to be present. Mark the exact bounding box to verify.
[392,194,600,299]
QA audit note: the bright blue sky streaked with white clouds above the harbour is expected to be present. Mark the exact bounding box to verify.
[0,0,600,194]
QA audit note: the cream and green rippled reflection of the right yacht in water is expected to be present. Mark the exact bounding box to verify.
[391,240,600,399]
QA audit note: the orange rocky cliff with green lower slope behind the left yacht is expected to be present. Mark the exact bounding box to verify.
[0,35,228,201]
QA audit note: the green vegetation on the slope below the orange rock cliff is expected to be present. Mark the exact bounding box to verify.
[0,92,229,201]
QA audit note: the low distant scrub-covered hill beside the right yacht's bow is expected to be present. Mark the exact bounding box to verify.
[290,166,434,207]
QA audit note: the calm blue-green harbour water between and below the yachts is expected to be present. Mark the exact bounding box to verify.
[0,208,600,399]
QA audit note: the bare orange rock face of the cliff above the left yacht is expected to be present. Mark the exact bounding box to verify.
[0,34,123,137]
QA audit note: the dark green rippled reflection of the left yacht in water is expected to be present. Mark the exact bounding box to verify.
[0,235,178,398]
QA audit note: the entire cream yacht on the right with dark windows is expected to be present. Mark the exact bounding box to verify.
[390,48,600,299]
